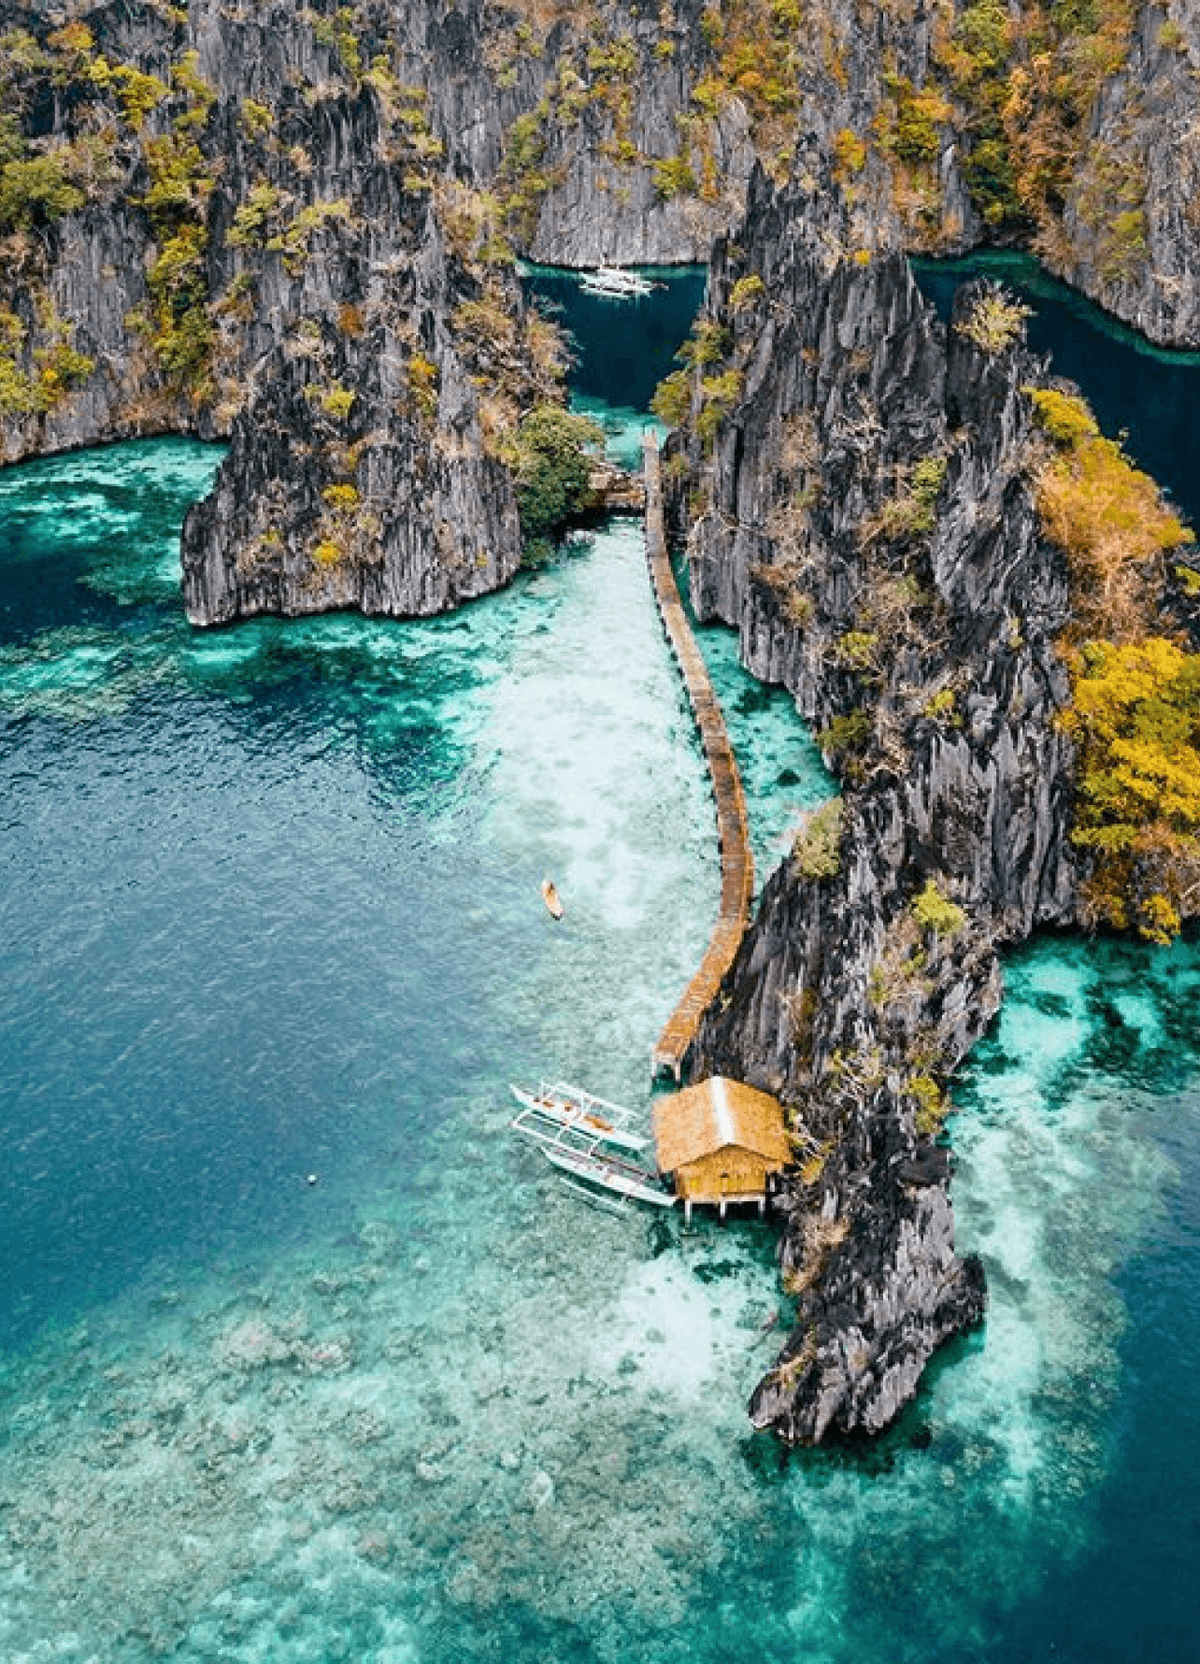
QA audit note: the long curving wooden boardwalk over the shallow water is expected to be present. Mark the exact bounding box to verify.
[646,434,754,1080]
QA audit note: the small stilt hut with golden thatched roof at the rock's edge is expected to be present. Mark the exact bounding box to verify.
[654,1075,792,1213]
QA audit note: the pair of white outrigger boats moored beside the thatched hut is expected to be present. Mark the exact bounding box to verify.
[511,1082,677,1208]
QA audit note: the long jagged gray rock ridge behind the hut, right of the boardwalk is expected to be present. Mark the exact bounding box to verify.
[659,168,1075,1443]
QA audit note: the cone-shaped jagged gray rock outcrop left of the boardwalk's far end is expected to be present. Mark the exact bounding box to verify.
[183,98,525,624]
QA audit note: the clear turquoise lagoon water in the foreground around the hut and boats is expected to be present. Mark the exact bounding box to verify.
[0,276,1200,1664]
